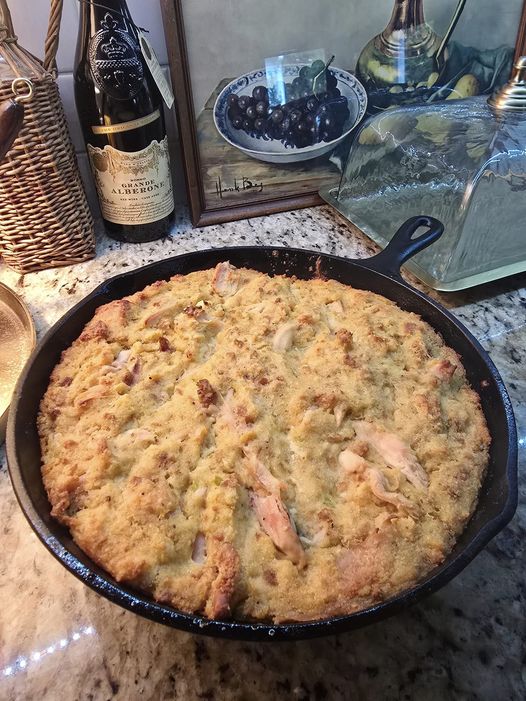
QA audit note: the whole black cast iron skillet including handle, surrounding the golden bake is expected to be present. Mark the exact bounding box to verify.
[7,217,517,640]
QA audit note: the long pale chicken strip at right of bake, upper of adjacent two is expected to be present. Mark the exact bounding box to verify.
[353,421,429,490]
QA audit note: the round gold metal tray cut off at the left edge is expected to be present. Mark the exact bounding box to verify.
[0,282,36,445]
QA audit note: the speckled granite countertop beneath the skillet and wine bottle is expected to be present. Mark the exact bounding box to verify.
[0,207,526,701]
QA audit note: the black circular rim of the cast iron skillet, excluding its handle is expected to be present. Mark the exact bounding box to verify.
[6,246,518,641]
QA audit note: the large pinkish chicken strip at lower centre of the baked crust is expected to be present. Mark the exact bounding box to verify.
[251,492,307,569]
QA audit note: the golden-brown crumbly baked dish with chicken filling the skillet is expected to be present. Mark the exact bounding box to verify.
[39,263,489,622]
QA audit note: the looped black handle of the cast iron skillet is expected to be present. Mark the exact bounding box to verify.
[359,216,444,278]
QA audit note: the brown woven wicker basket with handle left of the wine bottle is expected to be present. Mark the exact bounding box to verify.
[0,0,95,273]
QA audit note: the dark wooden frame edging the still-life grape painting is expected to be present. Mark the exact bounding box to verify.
[160,0,526,227]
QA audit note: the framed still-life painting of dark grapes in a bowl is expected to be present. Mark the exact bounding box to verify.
[161,0,526,226]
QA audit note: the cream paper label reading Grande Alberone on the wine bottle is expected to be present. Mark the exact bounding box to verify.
[87,136,174,225]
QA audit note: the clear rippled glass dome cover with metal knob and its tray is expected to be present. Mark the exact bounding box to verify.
[321,57,526,290]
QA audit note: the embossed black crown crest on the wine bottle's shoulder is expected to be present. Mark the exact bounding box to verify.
[88,12,144,100]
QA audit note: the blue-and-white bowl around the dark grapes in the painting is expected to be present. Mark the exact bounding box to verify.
[214,65,367,164]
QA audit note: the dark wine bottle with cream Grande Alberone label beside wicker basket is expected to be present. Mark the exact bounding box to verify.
[75,0,174,243]
